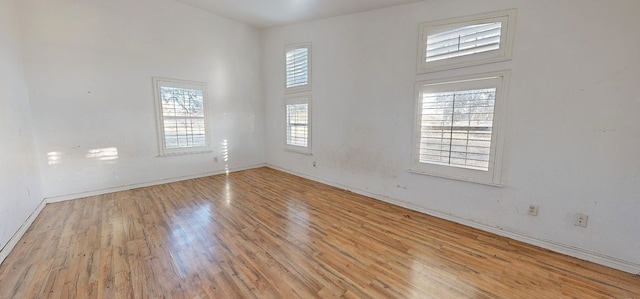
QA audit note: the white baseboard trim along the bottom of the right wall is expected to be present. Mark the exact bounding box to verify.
[266,163,640,275]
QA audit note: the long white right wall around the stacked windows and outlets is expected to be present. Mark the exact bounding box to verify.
[263,0,640,273]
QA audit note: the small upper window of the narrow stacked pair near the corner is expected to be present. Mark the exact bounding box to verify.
[285,43,311,93]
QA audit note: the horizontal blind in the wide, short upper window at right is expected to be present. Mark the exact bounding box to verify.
[426,22,502,62]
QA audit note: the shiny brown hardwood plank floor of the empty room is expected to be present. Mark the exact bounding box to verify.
[0,168,640,299]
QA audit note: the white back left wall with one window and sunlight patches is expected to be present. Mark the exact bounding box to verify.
[19,0,265,200]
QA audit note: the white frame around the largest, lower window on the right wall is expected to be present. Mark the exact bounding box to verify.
[409,71,510,186]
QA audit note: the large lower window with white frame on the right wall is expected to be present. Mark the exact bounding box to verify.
[412,72,508,185]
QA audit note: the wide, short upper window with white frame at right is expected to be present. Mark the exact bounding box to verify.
[418,10,515,73]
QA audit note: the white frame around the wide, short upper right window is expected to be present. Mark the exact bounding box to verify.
[417,9,516,74]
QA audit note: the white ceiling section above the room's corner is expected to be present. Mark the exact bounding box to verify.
[178,0,421,28]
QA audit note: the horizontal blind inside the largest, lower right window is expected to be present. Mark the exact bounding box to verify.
[419,88,496,171]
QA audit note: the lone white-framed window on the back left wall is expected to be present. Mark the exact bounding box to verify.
[153,78,211,156]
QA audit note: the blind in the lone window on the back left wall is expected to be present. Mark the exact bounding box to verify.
[160,86,206,149]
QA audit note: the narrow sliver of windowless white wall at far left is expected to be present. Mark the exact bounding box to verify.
[0,0,43,262]
